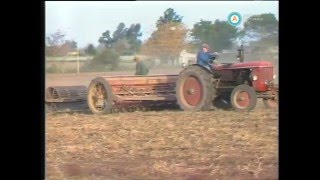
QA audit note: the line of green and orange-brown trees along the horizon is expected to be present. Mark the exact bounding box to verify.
[45,8,278,67]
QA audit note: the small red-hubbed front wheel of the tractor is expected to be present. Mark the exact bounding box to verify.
[230,84,257,111]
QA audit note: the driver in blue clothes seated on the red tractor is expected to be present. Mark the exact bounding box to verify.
[197,44,217,71]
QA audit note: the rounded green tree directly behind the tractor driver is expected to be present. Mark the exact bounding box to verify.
[191,20,237,51]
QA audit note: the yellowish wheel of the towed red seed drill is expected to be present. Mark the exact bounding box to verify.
[87,77,113,114]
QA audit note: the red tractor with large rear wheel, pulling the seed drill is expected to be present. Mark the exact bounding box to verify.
[176,46,278,111]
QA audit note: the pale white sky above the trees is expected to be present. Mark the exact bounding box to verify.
[45,1,279,47]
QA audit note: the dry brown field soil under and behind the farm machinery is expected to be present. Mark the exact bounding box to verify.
[45,72,278,180]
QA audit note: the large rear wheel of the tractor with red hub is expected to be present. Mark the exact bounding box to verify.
[176,66,215,111]
